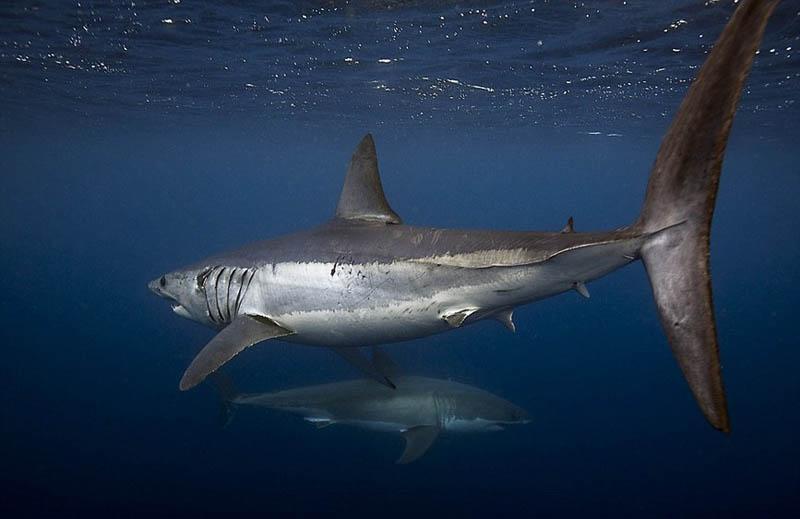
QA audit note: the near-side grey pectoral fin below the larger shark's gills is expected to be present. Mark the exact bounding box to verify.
[179,315,294,391]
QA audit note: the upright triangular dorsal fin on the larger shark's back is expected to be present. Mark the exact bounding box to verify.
[336,133,402,224]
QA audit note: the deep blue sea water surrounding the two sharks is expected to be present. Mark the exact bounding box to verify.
[0,0,800,517]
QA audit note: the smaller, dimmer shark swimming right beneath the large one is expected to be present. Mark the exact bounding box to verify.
[212,374,530,464]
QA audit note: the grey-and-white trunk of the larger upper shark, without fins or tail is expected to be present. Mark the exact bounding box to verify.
[172,219,649,347]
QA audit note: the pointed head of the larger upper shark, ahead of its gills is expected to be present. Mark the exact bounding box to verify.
[147,268,213,324]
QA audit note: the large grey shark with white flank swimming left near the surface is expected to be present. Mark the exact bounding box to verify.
[149,0,777,431]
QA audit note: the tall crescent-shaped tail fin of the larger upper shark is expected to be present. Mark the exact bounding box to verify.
[635,0,777,432]
